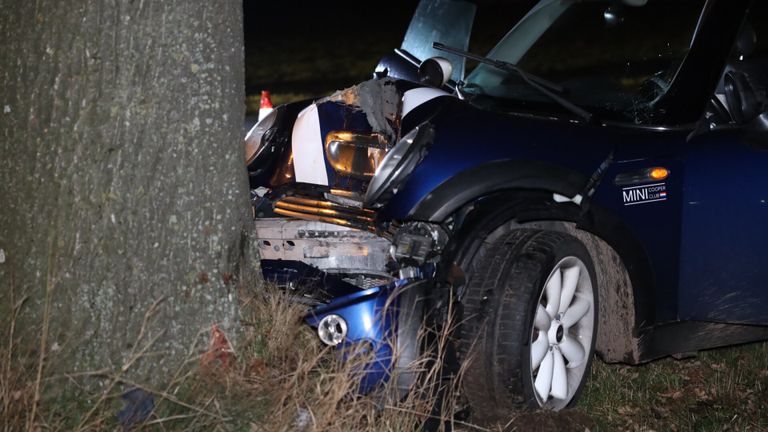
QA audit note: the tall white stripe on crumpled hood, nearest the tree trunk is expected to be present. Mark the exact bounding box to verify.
[291,104,328,186]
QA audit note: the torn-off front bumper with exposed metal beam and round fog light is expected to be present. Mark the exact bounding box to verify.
[255,217,443,394]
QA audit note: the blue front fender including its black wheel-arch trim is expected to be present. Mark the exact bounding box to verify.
[379,97,616,222]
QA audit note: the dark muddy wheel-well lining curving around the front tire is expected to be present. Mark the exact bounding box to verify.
[443,189,653,364]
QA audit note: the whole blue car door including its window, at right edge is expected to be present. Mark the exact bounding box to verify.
[678,2,768,324]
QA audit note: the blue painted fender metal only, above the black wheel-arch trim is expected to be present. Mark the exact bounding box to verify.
[380,99,614,219]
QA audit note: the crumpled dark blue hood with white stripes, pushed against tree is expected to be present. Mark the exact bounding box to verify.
[248,78,453,195]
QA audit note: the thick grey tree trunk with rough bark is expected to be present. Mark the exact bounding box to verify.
[0,0,250,392]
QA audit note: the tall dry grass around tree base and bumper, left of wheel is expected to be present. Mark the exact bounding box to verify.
[0,282,477,432]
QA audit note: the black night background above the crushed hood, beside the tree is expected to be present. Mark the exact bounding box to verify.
[243,0,533,94]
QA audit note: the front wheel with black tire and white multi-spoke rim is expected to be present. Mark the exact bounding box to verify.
[459,229,599,424]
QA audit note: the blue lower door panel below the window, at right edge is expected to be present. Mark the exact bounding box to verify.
[678,128,768,324]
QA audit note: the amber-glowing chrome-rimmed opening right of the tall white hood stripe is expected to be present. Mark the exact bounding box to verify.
[325,131,388,179]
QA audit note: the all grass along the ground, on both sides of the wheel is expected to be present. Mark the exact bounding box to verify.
[6,274,768,432]
